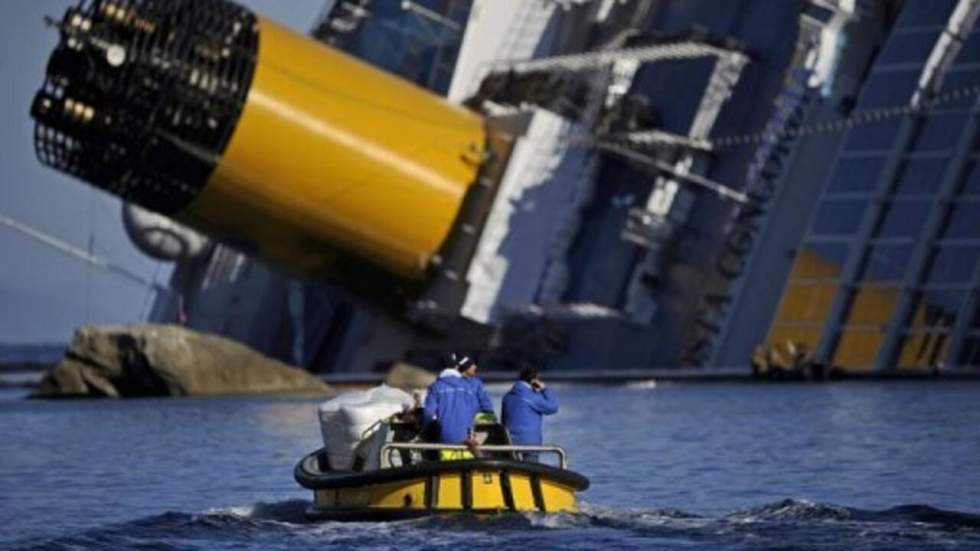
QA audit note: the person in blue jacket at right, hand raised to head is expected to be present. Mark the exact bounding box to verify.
[500,367,558,461]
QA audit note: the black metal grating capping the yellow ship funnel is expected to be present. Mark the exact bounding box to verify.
[31,0,259,214]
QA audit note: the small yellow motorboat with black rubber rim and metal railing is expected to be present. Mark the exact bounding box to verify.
[294,416,589,520]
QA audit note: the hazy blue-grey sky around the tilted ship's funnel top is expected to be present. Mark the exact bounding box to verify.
[0,0,332,343]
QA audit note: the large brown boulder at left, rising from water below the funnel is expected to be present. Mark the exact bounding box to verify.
[31,324,334,398]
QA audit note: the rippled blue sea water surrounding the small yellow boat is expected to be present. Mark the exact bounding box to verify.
[0,383,980,550]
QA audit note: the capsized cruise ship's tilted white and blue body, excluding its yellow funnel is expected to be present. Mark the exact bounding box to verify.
[118,0,980,372]
